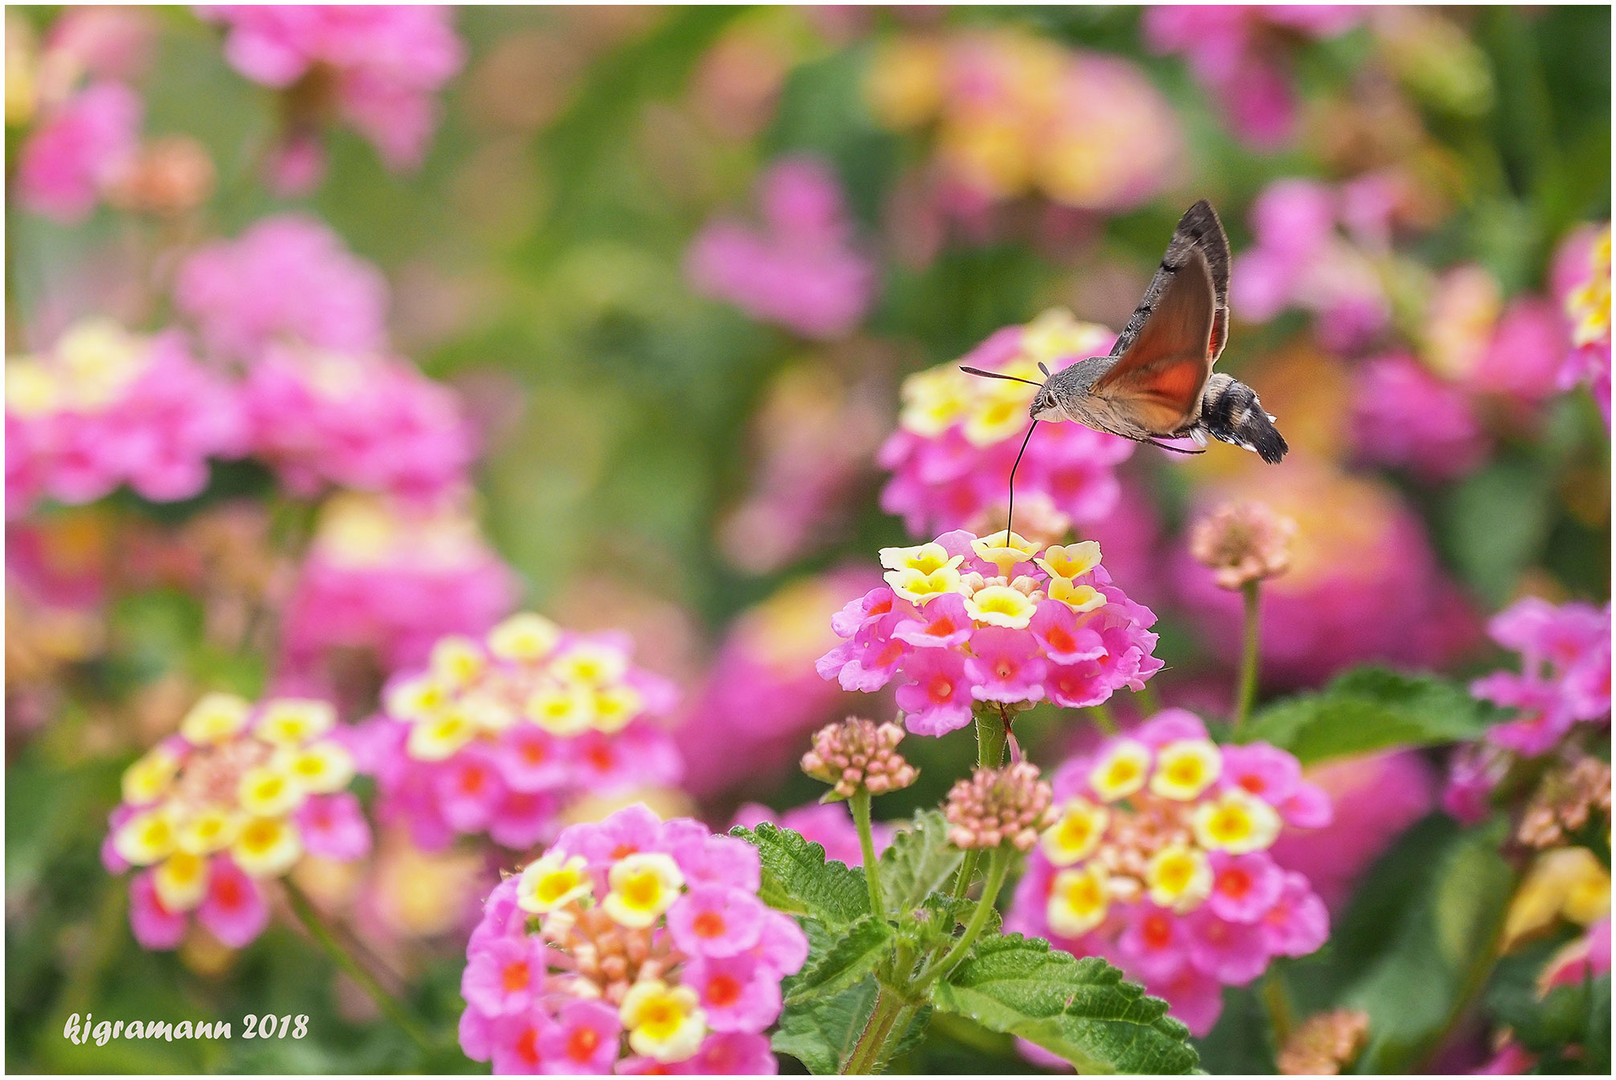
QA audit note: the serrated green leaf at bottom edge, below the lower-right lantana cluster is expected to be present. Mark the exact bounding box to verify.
[934,934,1199,1074]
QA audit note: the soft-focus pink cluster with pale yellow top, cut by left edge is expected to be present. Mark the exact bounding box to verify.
[5,320,247,519]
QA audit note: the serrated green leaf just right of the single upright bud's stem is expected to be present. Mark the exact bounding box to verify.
[1244,668,1493,765]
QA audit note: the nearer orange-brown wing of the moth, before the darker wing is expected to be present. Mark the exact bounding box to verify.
[1089,247,1217,435]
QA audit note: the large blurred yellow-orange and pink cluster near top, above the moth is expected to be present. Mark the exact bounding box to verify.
[865,29,1183,210]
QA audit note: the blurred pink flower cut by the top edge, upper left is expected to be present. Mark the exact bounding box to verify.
[197,5,465,170]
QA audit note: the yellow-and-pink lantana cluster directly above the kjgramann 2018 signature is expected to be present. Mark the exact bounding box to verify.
[102,694,370,949]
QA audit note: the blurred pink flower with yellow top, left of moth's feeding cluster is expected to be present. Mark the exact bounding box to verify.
[674,567,879,799]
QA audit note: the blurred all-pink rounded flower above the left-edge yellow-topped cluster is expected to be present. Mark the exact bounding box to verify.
[175,213,388,361]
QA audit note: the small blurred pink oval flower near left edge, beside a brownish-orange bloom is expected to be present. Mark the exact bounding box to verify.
[16,81,144,225]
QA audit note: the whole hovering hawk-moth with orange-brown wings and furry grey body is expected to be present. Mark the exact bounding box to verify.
[963,199,1290,464]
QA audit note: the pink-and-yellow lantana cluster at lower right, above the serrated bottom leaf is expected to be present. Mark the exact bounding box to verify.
[1005,710,1332,1035]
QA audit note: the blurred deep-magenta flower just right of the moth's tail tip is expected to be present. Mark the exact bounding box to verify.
[1353,352,1490,482]
